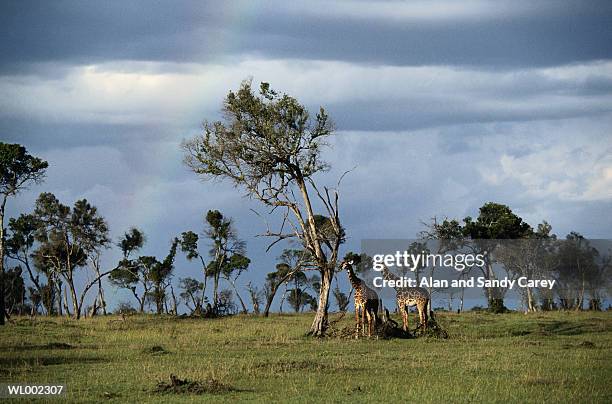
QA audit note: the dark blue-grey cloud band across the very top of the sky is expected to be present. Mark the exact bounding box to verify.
[0,1,612,73]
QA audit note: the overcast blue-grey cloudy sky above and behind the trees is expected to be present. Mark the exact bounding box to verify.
[0,0,612,310]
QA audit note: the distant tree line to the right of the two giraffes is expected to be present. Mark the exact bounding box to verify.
[424,202,612,312]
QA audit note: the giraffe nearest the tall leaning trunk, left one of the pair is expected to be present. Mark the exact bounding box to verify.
[341,261,379,338]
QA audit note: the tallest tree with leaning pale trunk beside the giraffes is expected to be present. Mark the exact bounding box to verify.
[184,81,342,336]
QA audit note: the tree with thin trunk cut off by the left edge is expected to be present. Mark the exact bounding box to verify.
[0,142,48,325]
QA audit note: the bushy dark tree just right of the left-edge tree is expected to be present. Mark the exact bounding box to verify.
[34,193,111,319]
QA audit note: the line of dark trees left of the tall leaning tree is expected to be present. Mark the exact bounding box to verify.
[0,143,332,319]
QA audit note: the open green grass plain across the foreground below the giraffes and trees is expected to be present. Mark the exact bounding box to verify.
[0,312,612,403]
